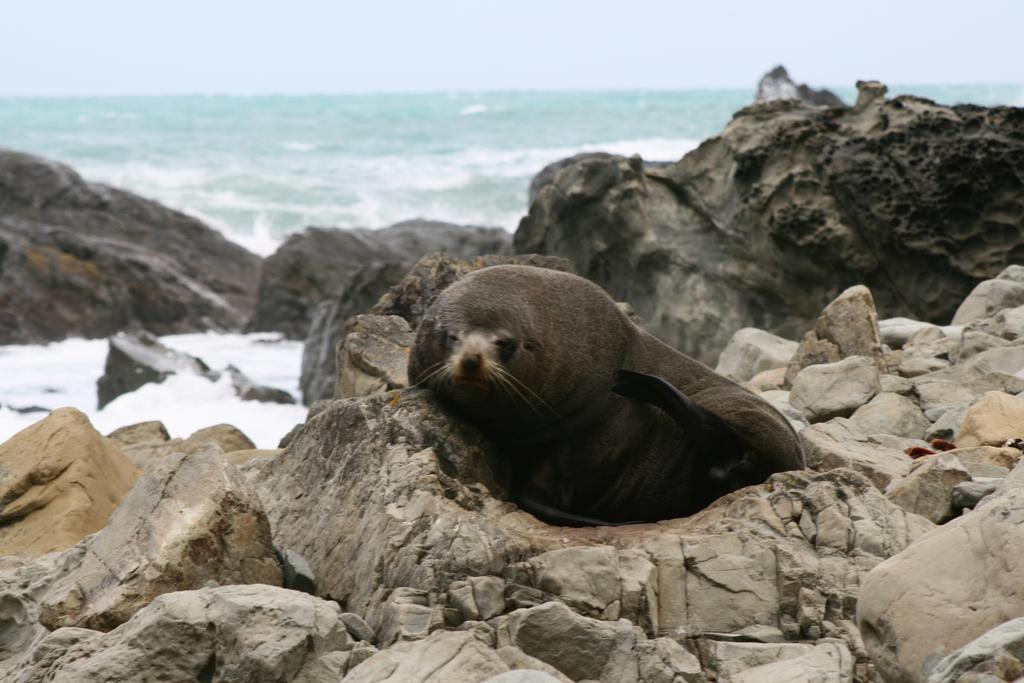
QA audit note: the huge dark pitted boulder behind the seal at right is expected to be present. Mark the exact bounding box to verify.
[515,84,1024,364]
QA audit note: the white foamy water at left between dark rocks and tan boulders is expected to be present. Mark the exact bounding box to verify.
[0,333,306,447]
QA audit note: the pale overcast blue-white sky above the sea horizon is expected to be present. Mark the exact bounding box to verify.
[0,0,1024,96]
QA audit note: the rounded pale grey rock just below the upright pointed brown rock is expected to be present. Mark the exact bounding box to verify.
[790,355,882,422]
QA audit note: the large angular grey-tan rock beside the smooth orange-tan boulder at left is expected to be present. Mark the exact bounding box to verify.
[40,453,282,631]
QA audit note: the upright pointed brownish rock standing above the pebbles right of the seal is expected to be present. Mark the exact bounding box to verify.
[785,285,886,383]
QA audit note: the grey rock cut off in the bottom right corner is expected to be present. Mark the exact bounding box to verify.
[928,617,1024,683]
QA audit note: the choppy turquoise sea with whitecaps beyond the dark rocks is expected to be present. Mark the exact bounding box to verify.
[0,85,1024,254]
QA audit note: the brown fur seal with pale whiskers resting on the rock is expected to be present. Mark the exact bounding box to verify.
[409,265,804,525]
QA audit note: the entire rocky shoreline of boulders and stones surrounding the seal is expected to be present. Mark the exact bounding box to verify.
[0,77,1024,683]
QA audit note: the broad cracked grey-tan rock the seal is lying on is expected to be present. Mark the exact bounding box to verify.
[255,390,931,680]
